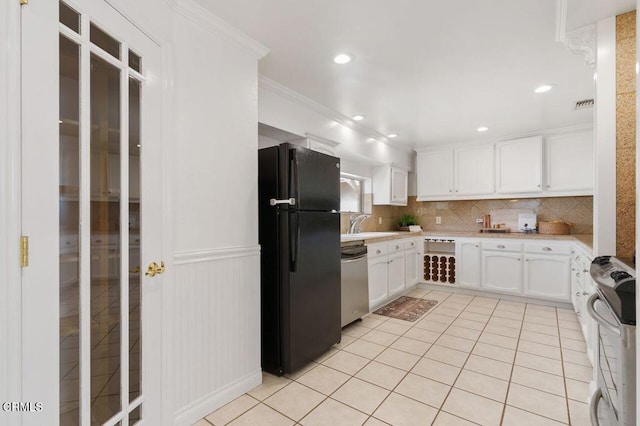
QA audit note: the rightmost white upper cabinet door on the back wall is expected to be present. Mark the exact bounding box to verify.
[544,132,594,194]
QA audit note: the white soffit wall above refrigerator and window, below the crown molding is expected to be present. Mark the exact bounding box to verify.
[258,78,414,170]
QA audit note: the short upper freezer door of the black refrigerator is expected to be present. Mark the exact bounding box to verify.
[280,144,340,211]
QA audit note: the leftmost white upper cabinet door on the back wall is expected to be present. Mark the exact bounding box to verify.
[418,149,453,201]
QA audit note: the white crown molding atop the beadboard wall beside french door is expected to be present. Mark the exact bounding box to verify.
[166,0,269,59]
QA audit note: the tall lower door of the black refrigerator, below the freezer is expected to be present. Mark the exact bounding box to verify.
[281,212,341,372]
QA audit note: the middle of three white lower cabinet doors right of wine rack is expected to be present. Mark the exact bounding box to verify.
[482,250,522,294]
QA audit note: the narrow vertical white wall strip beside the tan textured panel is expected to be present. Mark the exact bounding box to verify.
[593,17,616,256]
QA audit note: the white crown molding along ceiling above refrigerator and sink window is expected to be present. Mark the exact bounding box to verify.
[258,74,412,152]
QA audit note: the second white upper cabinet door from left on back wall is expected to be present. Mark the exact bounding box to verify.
[454,144,495,195]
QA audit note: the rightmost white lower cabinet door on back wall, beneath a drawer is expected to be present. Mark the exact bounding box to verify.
[524,254,571,302]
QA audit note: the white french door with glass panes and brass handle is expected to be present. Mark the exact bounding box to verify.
[21,0,164,426]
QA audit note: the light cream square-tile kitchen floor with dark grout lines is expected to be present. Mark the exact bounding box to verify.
[195,288,592,426]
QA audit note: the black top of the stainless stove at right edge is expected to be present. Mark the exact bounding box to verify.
[589,256,636,325]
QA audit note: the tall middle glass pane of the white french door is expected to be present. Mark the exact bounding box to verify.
[90,54,126,424]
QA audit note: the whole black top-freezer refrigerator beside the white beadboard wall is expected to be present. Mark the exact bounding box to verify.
[258,144,341,375]
